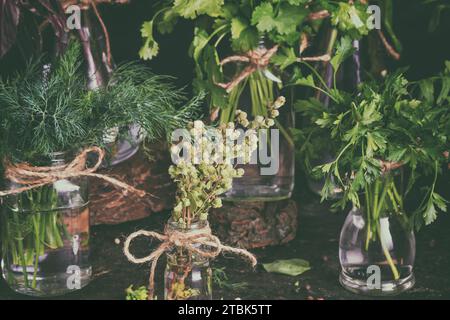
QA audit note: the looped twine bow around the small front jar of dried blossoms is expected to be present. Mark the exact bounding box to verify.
[123,222,257,300]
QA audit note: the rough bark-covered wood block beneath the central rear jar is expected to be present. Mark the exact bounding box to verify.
[209,200,298,249]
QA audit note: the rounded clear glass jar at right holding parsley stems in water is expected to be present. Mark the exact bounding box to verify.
[339,174,416,296]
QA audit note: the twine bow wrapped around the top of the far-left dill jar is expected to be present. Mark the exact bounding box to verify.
[0,147,146,197]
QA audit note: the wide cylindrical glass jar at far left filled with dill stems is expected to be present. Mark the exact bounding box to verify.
[1,153,92,297]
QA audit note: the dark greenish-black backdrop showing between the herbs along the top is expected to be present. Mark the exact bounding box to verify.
[0,0,450,85]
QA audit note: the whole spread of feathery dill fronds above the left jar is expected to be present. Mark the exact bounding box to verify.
[0,41,201,162]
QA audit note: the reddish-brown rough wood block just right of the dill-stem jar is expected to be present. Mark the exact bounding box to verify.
[90,146,175,225]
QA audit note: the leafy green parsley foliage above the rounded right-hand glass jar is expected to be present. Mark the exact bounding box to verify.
[297,62,450,228]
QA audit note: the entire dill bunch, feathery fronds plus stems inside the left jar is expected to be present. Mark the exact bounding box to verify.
[0,42,199,289]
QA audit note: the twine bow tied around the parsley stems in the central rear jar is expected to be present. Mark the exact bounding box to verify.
[217,45,278,92]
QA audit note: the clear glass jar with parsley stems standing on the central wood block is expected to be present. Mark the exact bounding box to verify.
[220,38,295,201]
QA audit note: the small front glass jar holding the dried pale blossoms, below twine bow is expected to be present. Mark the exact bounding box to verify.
[164,221,212,300]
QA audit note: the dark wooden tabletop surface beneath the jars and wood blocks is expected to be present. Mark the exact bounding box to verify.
[0,201,450,299]
